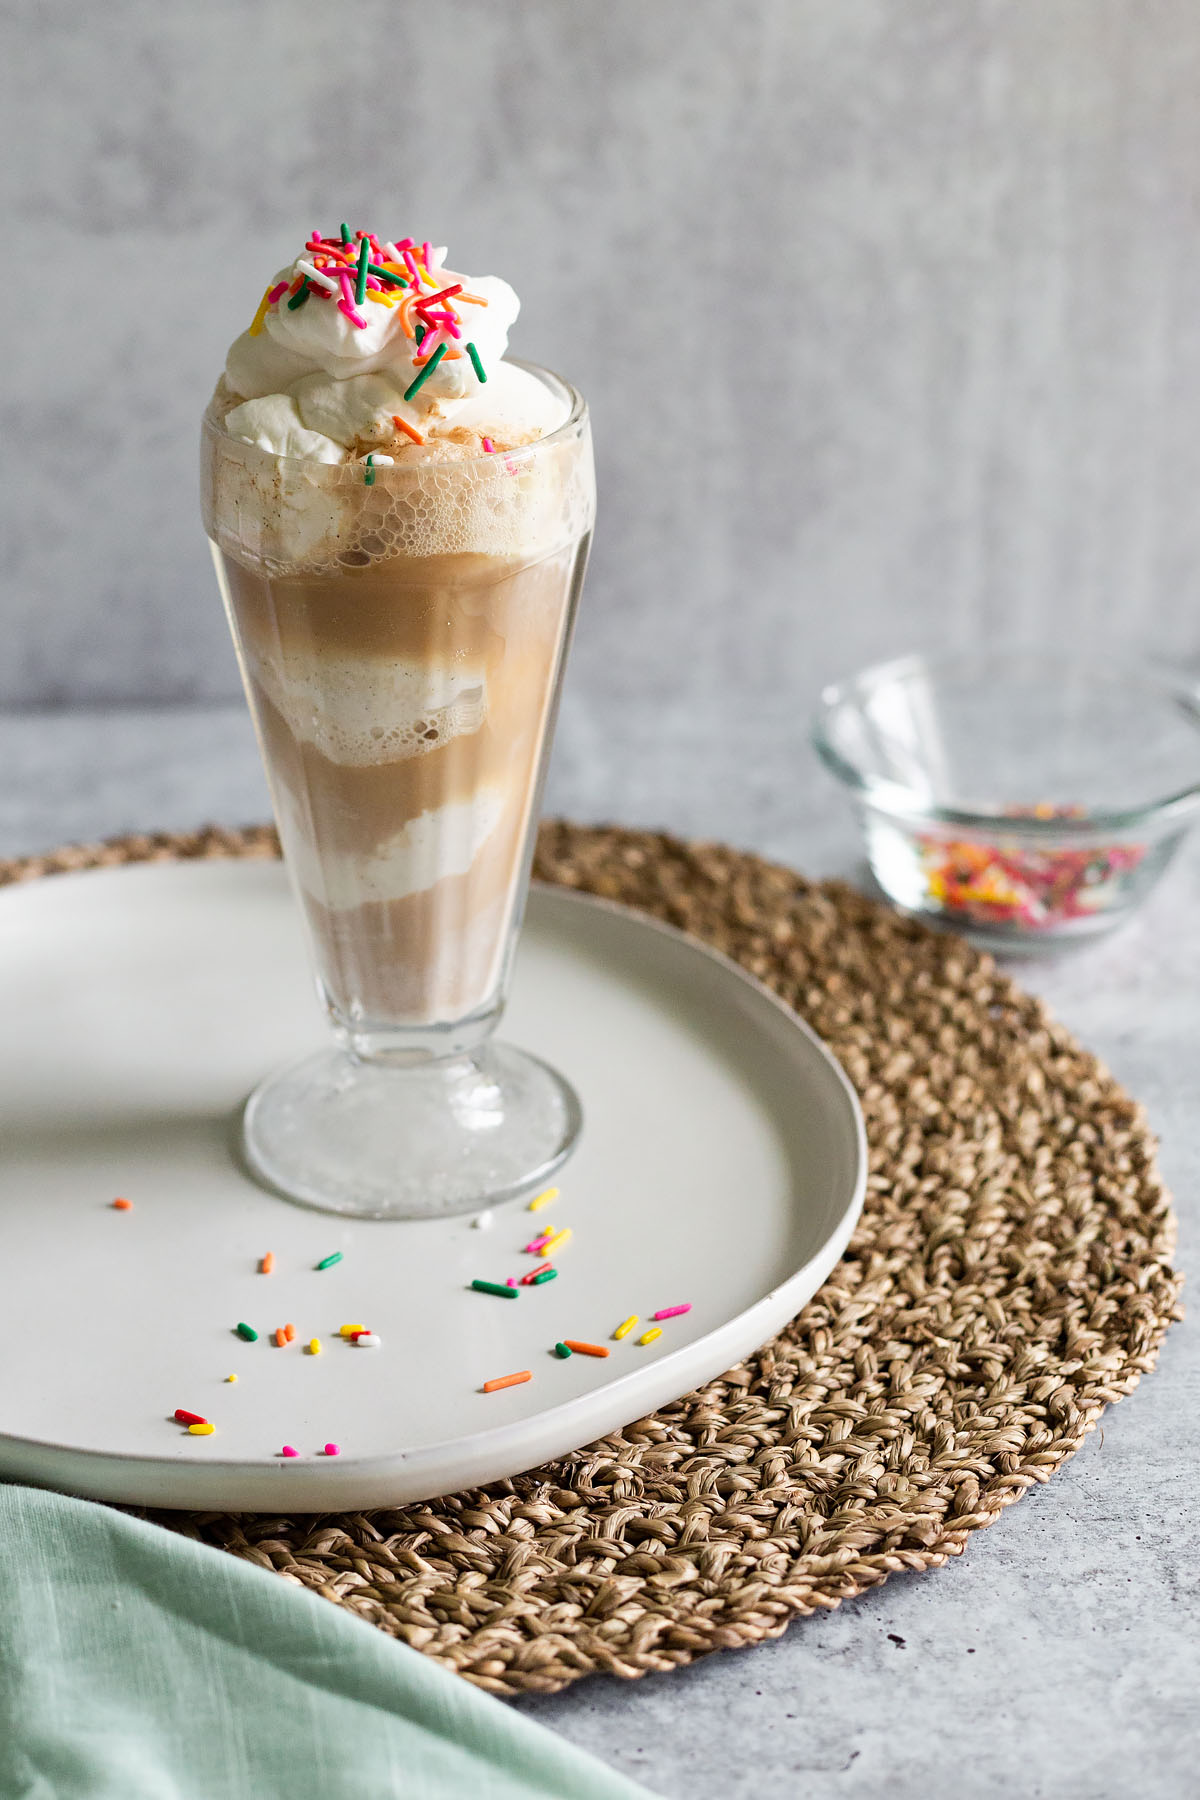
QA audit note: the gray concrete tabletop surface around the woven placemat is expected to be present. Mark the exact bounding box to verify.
[0,705,1200,1800]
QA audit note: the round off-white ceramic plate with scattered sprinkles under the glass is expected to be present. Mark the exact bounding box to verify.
[0,862,865,1510]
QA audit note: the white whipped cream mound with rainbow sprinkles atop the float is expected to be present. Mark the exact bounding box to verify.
[225,227,565,463]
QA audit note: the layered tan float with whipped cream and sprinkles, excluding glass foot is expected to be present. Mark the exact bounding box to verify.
[203,227,594,1215]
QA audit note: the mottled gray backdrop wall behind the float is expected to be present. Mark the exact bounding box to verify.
[0,0,1200,709]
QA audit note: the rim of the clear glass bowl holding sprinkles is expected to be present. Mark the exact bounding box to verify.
[811,644,1200,844]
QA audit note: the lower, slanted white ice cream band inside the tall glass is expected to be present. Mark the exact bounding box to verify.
[286,787,506,913]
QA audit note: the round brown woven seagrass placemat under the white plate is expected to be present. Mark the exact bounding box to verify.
[0,823,1178,1694]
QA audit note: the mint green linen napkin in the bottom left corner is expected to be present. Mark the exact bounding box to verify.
[0,1485,648,1800]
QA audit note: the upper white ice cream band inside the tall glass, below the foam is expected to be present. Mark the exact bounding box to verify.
[254,653,488,769]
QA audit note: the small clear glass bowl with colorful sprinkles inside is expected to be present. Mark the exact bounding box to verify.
[813,648,1200,952]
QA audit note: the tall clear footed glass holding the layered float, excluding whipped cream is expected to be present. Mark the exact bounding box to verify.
[203,369,596,1219]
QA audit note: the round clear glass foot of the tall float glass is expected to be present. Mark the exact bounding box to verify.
[243,1044,583,1219]
